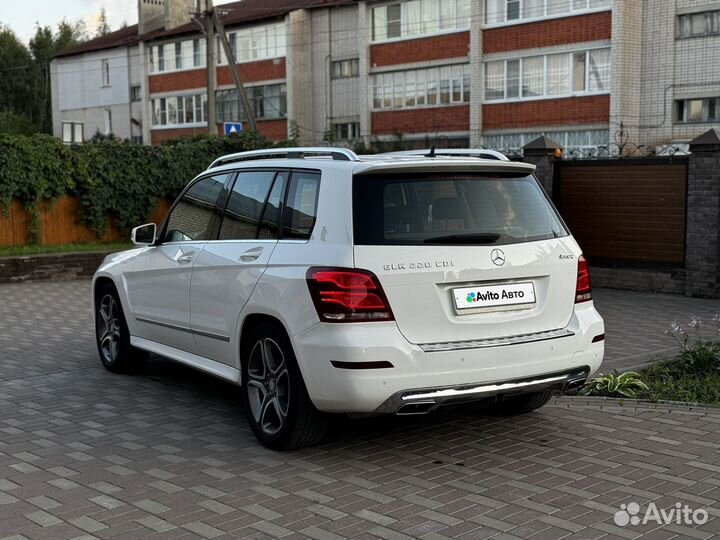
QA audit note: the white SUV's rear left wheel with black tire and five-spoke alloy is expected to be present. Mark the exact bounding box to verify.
[241,323,329,450]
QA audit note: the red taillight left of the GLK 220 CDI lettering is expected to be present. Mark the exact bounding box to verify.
[307,268,394,322]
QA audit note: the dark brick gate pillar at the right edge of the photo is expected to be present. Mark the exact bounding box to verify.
[685,129,720,298]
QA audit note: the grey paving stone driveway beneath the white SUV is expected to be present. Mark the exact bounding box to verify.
[0,282,720,540]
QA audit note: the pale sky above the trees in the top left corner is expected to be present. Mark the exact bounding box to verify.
[0,0,239,44]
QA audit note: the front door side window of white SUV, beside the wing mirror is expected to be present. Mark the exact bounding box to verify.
[164,174,228,242]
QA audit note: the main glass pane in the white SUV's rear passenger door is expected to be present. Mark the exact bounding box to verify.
[220,171,275,240]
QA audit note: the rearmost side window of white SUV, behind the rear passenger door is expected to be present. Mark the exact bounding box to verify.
[283,172,320,239]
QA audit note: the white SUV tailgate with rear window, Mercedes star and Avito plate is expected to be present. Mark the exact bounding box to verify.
[353,169,579,343]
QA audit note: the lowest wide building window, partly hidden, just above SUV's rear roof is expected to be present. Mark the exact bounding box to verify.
[483,129,610,153]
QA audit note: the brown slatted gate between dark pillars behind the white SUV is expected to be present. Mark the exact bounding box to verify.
[554,158,687,265]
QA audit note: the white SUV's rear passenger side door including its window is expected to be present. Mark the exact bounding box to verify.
[190,170,289,365]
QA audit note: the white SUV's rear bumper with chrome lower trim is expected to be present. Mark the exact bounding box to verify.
[291,302,605,413]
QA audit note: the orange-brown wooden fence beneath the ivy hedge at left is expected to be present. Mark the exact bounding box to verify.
[0,195,171,247]
